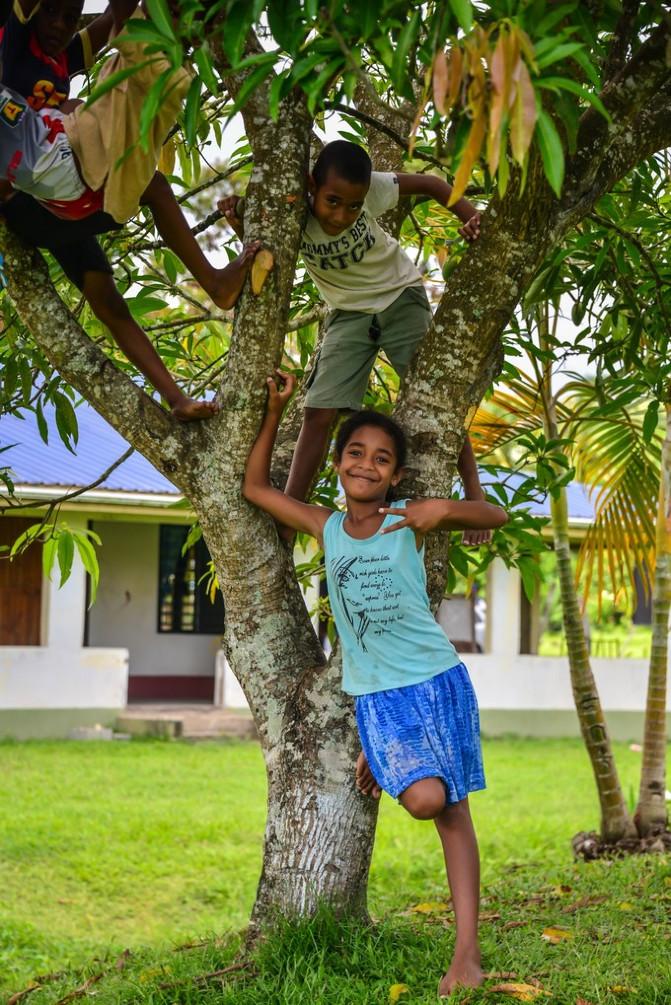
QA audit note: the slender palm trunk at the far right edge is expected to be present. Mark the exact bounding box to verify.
[635,401,671,836]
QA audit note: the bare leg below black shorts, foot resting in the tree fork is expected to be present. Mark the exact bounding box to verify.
[81,270,218,421]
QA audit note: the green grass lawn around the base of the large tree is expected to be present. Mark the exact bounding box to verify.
[0,740,671,1005]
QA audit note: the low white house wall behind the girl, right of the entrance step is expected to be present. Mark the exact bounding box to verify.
[218,653,671,740]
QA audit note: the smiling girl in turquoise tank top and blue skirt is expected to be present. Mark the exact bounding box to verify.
[243,371,506,997]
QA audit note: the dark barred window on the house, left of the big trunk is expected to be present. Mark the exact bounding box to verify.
[158,524,225,635]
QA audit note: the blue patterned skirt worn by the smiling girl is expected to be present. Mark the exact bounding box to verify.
[357,663,485,804]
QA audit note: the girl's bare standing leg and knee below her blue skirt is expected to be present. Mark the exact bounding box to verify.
[400,778,483,997]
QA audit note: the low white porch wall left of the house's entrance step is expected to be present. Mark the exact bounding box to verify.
[0,645,129,740]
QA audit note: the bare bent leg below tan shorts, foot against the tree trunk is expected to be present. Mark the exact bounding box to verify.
[141,171,260,311]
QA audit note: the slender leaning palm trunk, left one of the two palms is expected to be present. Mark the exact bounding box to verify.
[538,307,636,843]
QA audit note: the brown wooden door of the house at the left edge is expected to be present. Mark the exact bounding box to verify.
[0,517,42,645]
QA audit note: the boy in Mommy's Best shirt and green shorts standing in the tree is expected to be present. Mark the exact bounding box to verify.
[219,140,489,544]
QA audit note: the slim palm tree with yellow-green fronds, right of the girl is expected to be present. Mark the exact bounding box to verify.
[470,305,671,843]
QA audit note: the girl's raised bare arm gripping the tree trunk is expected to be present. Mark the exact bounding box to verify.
[242,370,332,541]
